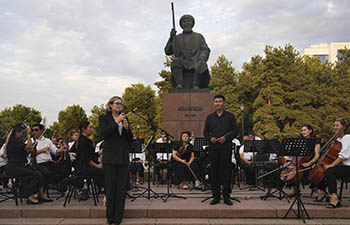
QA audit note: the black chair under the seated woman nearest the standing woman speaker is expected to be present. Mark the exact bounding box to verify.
[63,175,99,207]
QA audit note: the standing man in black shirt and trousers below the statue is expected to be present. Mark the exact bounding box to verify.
[204,95,238,205]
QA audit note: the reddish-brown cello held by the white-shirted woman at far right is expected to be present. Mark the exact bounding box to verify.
[308,123,350,184]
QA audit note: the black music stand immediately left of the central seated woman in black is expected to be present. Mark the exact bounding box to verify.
[154,143,186,202]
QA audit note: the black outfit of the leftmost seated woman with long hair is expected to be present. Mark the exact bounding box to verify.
[6,137,45,198]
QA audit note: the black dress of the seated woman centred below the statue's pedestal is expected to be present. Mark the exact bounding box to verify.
[171,143,198,185]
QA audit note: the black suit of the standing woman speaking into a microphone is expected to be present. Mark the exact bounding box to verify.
[99,113,132,224]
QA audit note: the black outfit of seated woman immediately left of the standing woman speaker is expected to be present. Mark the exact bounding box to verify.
[76,135,105,189]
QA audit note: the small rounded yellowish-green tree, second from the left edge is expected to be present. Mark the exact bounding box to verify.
[50,105,88,138]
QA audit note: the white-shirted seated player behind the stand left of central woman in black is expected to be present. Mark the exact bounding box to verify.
[154,136,172,184]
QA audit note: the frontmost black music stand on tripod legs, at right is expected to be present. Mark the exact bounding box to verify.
[281,138,315,223]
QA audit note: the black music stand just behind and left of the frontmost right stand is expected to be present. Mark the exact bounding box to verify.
[255,139,291,203]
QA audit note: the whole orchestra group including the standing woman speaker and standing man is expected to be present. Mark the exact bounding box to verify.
[0,106,350,216]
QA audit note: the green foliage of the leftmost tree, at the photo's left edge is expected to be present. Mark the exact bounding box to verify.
[0,104,42,137]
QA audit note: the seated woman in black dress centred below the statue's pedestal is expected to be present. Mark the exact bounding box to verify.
[172,131,199,189]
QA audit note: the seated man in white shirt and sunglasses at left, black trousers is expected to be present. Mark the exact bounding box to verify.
[32,124,66,185]
